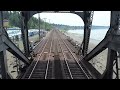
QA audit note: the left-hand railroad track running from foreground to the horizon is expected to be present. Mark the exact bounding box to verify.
[22,32,53,79]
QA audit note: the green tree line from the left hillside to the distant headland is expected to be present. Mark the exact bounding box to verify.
[3,11,85,30]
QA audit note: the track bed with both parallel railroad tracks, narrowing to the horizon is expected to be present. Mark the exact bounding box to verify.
[22,30,92,79]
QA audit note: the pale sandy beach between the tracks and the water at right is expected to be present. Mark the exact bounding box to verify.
[65,32,107,74]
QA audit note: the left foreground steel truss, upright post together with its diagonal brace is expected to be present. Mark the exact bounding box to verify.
[0,11,30,79]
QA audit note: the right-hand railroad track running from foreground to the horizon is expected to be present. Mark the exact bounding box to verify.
[57,31,92,79]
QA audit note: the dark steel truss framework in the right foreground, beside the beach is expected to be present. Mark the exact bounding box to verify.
[81,11,120,79]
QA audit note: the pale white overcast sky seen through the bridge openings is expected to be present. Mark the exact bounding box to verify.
[34,11,110,26]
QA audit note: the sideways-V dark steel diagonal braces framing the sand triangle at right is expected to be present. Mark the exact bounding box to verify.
[81,29,112,79]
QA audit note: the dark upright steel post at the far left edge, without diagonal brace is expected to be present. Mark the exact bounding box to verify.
[0,11,12,79]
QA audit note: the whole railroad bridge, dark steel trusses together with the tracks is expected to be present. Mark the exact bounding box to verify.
[0,11,120,79]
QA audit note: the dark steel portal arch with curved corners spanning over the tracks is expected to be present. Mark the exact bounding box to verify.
[21,11,93,57]
